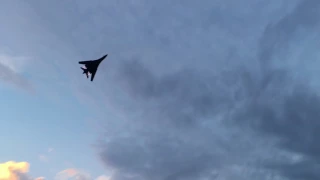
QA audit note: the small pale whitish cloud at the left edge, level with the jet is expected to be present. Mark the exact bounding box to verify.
[0,54,33,92]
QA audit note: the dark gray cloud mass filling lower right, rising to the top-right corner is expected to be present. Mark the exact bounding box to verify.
[96,1,320,180]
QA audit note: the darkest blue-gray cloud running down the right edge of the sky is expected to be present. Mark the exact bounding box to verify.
[235,1,320,180]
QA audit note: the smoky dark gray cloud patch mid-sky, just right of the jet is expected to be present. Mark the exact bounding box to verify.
[116,61,232,126]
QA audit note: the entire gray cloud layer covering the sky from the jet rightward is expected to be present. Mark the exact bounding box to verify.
[20,0,320,180]
